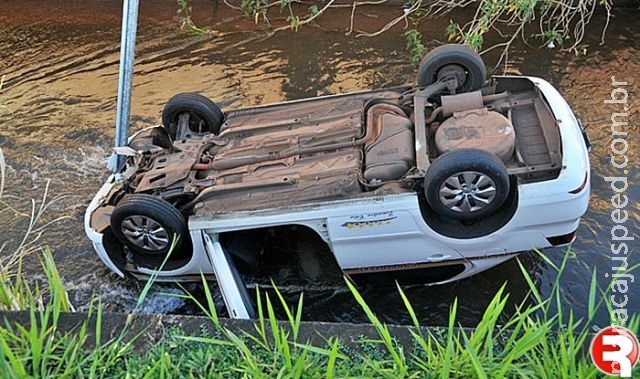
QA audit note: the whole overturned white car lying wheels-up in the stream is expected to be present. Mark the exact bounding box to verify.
[85,45,590,317]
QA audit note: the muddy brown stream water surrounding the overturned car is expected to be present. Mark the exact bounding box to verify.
[0,0,640,324]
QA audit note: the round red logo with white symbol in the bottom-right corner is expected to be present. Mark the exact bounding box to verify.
[591,326,640,378]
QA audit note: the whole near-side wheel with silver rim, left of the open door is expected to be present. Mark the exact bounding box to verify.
[110,194,187,257]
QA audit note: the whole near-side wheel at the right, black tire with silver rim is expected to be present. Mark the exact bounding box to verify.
[424,149,509,220]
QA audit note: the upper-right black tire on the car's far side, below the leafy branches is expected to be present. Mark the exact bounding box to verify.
[417,44,487,93]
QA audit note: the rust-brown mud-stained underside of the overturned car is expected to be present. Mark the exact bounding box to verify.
[112,84,559,221]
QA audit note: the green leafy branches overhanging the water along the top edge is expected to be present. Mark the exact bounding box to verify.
[178,0,613,67]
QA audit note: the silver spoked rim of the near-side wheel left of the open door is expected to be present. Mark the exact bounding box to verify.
[121,215,169,251]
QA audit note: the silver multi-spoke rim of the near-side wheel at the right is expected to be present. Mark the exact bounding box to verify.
[439,171,496,213]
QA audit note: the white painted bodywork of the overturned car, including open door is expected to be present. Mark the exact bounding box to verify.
[84,78,590,317]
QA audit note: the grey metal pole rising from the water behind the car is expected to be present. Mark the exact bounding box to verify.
[109,0,139,172]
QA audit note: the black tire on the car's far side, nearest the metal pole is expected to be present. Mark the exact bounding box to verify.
[162,92,224,140]
